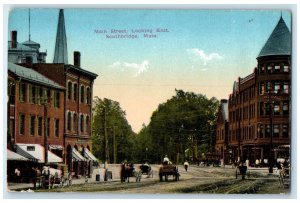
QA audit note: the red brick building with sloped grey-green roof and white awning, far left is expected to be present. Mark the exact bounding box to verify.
[7,63,65,163]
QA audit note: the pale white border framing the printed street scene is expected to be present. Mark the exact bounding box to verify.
[0,0,300,202]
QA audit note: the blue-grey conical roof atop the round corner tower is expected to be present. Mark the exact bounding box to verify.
[258,17,292,57]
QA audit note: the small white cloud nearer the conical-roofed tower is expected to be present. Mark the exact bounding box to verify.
[186,48,223,66]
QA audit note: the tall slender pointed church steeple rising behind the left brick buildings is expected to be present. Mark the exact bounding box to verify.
[53,9,68,64]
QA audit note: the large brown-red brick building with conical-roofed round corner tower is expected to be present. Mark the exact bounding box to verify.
[216,17,291,164]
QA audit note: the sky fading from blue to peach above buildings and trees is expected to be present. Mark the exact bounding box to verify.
[8,8,291,133]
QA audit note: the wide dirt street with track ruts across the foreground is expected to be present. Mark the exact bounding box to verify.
[13,165,289,194]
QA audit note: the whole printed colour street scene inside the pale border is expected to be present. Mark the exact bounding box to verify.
[5,7,295,198]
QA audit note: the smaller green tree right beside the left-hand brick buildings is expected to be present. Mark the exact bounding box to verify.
[92,97,136,163]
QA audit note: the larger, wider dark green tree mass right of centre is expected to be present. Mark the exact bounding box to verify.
[136,89,219,162]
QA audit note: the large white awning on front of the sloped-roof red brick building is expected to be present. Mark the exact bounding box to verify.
[16,143,63,163]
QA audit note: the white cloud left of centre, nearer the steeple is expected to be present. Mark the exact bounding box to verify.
[109,60,149,77]
